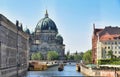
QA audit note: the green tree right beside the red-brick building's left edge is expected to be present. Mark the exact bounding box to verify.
[83,50,92,64]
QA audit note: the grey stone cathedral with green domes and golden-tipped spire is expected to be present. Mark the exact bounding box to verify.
[26,10,65,60]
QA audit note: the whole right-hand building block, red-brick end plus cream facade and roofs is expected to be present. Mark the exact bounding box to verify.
[92,25,120,63]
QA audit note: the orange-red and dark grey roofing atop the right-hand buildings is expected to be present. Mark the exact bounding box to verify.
[94,26,120,41]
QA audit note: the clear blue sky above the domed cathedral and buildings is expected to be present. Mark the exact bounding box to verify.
[0,0,120,53]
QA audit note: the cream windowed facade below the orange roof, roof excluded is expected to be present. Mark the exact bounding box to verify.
[97,37,120,59]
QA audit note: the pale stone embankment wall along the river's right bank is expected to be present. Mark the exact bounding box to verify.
[80,65,120,77]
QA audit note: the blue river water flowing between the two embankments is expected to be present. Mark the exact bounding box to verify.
[26,64,83,77]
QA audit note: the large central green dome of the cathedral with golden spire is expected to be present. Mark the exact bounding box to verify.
[36,11,58,32]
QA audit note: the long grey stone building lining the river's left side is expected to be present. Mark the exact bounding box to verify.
[0,14,29,77]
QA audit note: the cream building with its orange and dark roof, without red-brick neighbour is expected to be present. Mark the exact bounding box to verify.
[96,26,120,60]
